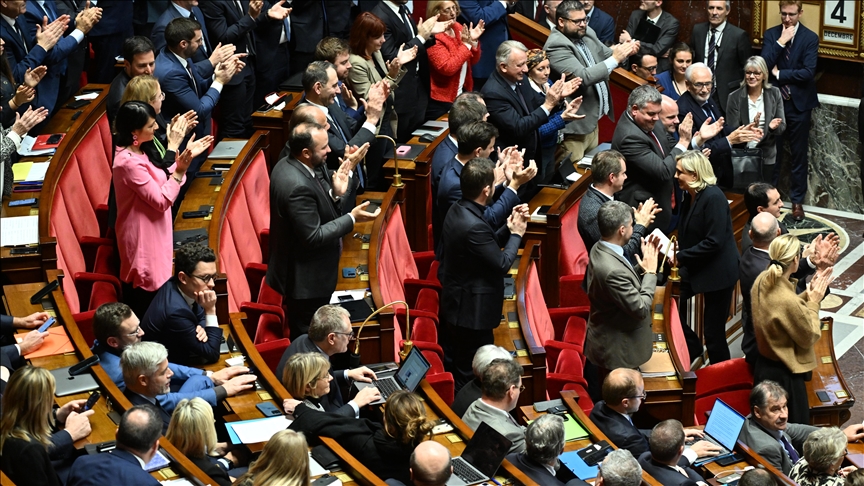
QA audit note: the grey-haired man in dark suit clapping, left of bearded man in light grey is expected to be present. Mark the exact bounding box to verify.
[481,40,581,184]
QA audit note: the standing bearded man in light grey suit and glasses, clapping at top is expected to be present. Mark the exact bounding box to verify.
[543,0,639,160]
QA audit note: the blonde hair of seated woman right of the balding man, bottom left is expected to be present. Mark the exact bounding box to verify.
[165,397,216,458]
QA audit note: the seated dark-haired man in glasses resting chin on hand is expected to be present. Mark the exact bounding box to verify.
[141,243,222,365]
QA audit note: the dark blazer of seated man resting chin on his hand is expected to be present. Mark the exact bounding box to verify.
[141,277,222,366]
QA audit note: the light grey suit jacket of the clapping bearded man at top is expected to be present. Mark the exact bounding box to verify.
[543,27,616,136]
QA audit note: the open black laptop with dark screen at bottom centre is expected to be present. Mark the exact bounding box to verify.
[447,422,513,486]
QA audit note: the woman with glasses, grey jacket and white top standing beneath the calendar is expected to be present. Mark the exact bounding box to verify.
[726,56,786,182]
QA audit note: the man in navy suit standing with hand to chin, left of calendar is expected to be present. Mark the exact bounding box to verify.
[762,0,819,221]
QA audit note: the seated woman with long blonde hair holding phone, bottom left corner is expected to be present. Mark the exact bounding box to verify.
[0,366,94,486]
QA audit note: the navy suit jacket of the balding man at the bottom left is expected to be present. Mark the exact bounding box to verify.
[66,449,160,486]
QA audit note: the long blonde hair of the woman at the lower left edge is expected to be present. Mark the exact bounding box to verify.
[0,365,54,450]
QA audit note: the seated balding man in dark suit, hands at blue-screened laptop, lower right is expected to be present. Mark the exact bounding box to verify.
[590,368,720,466]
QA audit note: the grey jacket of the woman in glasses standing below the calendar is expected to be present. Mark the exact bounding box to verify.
[725,87,786,164]
